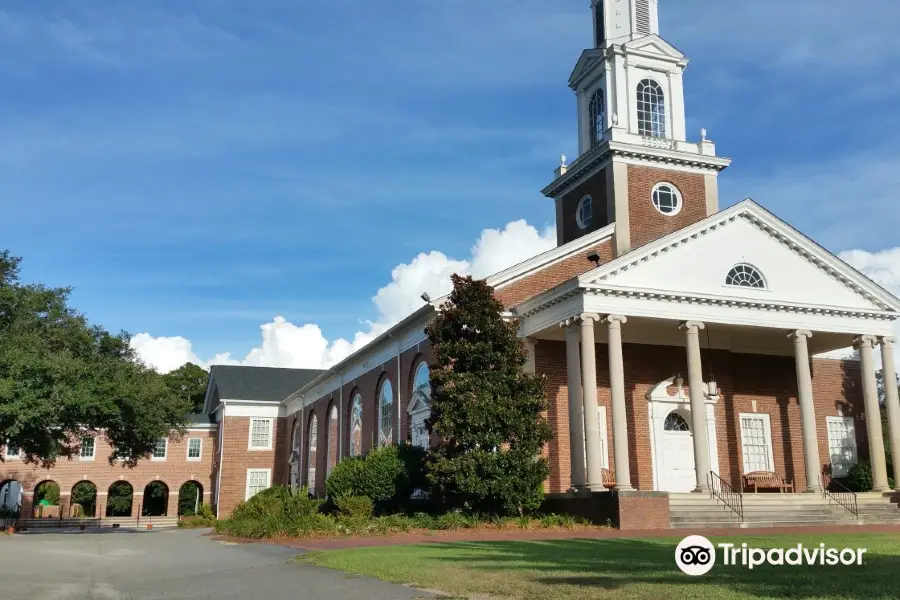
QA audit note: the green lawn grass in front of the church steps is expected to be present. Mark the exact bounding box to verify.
[303,532,900,600]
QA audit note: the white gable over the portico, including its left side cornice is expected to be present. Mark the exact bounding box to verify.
[514,199,900,318]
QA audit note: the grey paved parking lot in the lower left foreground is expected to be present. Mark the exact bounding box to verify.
[0,530,430,600]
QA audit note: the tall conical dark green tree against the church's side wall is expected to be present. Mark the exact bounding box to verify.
[427,275,552,514]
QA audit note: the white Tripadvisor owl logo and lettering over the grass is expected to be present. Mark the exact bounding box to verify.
[675,535,866,577]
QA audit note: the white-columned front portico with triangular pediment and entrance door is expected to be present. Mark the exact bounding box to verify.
[514,202,900,493]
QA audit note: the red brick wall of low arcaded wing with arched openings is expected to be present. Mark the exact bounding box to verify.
[0,431,218,516]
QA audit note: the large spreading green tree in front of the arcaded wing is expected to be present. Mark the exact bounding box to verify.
[0,251,190,465]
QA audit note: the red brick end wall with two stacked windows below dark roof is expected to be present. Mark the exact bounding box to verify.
[218,417,290,518]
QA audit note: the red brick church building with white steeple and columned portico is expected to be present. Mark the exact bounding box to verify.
[0,0,900,528]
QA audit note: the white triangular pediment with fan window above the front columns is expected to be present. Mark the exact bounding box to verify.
[581,202,898,311]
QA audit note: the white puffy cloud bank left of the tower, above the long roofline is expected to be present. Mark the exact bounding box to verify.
[131,220,556,373]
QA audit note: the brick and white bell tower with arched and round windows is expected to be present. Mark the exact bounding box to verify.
[543,0,731,256]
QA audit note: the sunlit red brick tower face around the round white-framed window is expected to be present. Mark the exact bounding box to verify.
[628,165,707,248]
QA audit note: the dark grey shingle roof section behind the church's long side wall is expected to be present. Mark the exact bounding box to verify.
[209,365,322,401]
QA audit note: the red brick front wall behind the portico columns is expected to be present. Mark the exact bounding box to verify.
[536,341,867,493]
